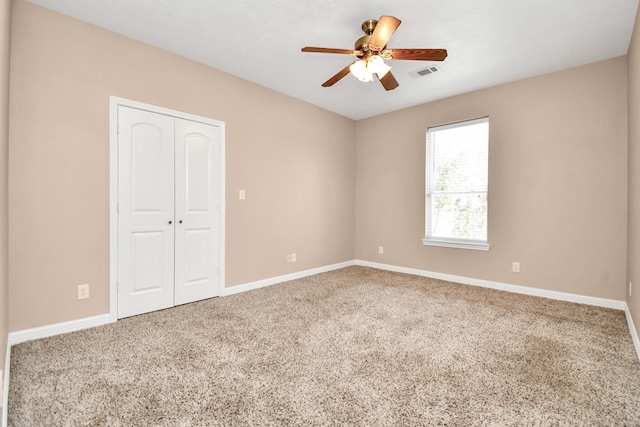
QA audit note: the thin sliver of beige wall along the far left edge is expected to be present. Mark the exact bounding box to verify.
[0,0,11,419]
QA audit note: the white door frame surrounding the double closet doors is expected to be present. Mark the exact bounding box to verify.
[109,96,226,322]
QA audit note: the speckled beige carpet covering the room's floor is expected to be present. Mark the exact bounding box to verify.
[8,267,640,427]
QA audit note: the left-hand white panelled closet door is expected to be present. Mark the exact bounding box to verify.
[118,107,174,318]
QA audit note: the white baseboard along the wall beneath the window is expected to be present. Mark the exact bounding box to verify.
[355,260,627,310]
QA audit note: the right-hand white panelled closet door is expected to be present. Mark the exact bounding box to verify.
[175,119,220,305]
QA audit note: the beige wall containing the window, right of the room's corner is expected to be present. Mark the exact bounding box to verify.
[356,57,628,300]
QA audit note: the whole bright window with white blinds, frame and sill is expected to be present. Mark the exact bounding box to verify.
[422,118,489,251]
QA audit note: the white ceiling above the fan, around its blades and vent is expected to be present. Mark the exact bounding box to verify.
[23,0,638,120]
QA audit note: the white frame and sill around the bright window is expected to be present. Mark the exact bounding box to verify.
[422,116,491,251]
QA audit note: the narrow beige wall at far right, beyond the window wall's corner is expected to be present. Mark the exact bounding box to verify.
[627,5,640,331]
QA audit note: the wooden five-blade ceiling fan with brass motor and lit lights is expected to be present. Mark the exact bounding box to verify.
[302,16,447,90]
